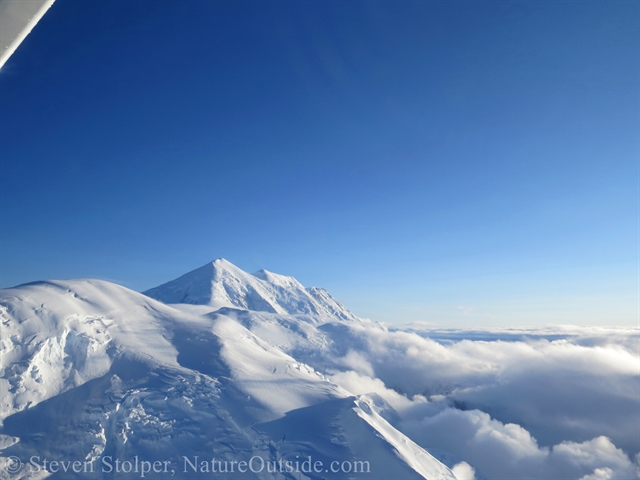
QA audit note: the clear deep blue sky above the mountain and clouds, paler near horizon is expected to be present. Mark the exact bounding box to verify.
[0,0,640,326]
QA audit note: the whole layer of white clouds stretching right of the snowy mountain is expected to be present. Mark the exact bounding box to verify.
[324,323,640,480]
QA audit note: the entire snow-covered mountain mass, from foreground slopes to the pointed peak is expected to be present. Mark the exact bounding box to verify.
[0,260,455,480]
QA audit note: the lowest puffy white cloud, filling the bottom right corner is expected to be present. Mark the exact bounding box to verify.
[400,408,638,480]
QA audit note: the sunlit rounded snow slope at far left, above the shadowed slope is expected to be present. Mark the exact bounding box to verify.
[0,280,178,421]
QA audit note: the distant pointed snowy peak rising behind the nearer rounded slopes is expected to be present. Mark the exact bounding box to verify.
[144,258,358,320]
